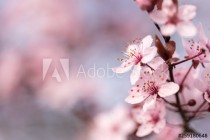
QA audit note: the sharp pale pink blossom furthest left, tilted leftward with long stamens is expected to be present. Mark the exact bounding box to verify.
[113,35,157,85]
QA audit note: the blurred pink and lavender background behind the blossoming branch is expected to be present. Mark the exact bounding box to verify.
[0,0,210,140]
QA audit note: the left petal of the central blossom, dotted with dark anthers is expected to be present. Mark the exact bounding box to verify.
[125,87,149,104]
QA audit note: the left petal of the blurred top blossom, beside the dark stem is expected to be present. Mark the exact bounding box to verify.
[150,10,168,24]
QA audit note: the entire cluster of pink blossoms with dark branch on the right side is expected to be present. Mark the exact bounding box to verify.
[110,0,210,139]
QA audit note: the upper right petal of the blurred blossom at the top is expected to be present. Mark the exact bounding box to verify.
[178,5,196,21]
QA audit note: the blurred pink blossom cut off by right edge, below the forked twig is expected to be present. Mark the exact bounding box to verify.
[195,66,210,103]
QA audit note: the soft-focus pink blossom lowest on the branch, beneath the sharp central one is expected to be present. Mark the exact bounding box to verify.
[133,100,166,137]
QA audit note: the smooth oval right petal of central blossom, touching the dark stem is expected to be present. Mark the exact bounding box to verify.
[158,82,179,97]
